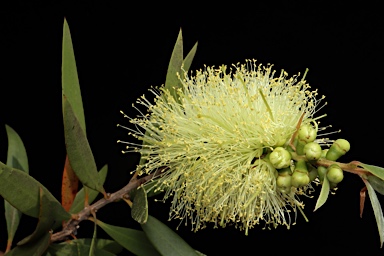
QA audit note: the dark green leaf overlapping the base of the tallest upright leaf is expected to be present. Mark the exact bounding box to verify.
[63,96,105,194]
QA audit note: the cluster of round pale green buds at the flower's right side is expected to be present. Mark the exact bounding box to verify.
[267,122,350,193]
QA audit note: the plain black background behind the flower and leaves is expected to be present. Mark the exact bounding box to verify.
[0,1,384,255]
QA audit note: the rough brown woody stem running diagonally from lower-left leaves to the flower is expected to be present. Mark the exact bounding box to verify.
[51,173,155,242]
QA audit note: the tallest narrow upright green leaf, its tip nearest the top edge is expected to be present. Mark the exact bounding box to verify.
[61,19,86,132]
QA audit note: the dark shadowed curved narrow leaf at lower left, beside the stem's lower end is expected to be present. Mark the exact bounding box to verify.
[17,188,55,245]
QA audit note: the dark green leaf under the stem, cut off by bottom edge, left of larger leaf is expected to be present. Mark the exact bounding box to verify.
[96,220,160,256]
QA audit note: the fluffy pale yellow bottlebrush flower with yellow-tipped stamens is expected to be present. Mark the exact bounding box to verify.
[118,61,324,233]
